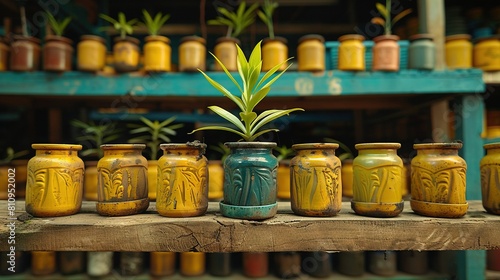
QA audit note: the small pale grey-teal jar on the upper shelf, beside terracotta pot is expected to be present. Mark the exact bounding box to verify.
[408,34,436,70]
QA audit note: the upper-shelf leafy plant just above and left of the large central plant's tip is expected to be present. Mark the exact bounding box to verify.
[207,1,259,38]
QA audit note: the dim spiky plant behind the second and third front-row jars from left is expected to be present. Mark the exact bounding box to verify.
[128,116,183,160]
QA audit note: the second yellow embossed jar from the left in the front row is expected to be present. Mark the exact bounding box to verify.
[97,144,149,216]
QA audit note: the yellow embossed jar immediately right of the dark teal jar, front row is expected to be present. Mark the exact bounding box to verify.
[290,143,342,216]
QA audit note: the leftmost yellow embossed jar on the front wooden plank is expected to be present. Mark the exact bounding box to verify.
[26,144,84,217]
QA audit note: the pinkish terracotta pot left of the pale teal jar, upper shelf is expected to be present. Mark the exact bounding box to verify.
[372,35,400,71]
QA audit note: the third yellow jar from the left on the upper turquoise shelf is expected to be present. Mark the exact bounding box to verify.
[144,35,172,72]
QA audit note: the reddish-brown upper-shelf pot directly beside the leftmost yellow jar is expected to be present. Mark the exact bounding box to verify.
[43,35,74,72]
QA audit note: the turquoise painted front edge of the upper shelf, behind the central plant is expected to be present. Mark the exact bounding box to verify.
[0,69,484,97]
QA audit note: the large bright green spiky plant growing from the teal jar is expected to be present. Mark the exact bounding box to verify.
[191,42,304,141]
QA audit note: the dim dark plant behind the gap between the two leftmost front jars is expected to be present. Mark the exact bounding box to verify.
[71,120,121,158]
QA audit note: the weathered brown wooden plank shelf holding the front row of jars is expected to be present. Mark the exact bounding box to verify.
[0,201,500,252]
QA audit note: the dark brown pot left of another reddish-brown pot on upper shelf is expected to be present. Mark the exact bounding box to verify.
[10,35,40,71]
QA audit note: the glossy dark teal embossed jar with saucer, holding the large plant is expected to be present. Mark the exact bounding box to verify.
[220,142,278,220]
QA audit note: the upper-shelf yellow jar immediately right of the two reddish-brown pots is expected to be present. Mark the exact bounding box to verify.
[76,35,106,72]
